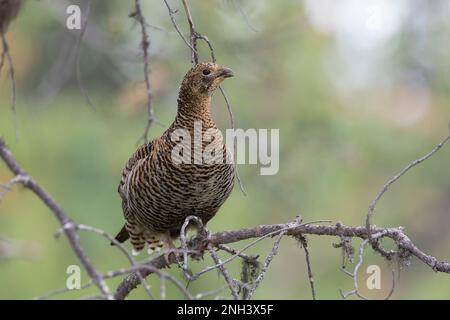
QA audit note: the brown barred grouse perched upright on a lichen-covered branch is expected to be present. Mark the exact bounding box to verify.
[112,62,235,258]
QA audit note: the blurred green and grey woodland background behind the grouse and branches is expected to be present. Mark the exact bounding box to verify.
[0,0,450,299]
